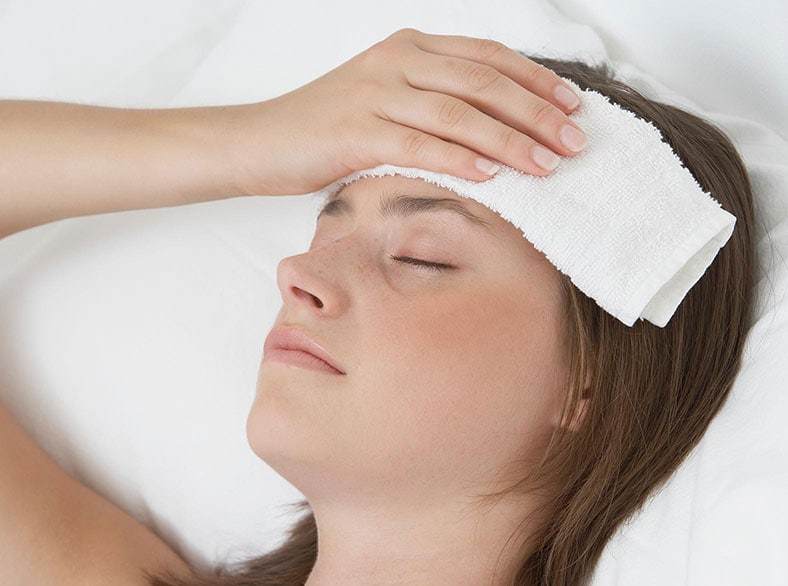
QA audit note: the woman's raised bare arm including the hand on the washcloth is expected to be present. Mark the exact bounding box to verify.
[0,30,578,238]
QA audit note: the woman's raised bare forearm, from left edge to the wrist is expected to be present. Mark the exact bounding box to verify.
[0,101,248,237]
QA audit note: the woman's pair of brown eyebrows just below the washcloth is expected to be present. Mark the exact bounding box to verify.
[316,191,494,235]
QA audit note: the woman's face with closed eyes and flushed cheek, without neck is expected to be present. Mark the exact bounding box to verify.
[247,177,566,501]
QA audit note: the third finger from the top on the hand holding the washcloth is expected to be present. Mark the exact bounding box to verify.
[381,90,559,176]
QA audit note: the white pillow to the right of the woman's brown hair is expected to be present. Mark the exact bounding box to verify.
[594,69,788,586]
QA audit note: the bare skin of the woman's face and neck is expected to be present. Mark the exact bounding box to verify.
[252,177,584,586]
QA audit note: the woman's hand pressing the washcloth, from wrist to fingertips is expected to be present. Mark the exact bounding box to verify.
[228,29,579,195]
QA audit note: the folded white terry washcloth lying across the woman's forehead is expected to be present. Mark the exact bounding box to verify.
[316,80,736,327]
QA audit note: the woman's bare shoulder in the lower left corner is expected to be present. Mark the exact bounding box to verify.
[0,405,194,586]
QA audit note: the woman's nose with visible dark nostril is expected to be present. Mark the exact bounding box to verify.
[276,251,348,317]
